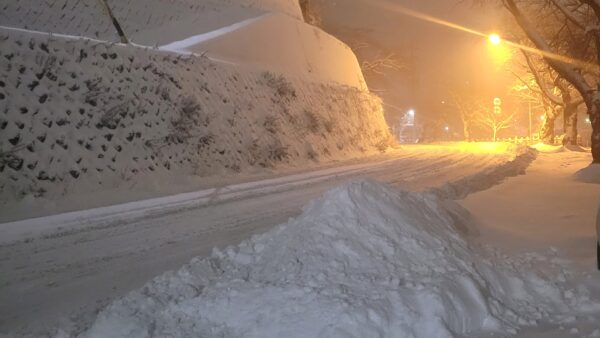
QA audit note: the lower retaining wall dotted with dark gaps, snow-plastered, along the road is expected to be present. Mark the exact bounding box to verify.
[0,30,389,207]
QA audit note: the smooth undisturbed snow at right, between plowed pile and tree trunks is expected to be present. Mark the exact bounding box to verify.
[461,152,600,337]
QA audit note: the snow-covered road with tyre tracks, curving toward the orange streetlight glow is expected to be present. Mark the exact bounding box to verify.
[0,146,528,333]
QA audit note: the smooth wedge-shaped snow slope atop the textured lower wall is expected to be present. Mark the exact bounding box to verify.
[173,13,367,90]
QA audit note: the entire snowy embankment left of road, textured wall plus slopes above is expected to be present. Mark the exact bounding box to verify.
[0,0,390,210]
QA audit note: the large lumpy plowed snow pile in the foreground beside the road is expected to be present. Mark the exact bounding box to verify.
[78,181,597,337]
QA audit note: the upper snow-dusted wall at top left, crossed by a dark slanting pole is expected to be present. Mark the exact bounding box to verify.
[0,0,302,45]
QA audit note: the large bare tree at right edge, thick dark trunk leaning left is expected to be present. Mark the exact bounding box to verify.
[502,0,600,163]
